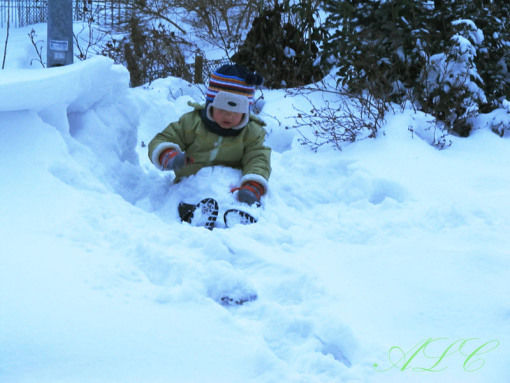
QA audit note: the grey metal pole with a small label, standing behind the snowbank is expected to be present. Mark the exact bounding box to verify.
[47,0,73,68]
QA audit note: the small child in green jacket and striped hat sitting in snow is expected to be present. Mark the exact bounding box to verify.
[149,65,271,230]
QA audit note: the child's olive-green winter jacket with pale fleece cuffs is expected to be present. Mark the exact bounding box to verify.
[149,103,271,190]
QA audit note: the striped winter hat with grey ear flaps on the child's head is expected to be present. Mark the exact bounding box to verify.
[206,65,263,129]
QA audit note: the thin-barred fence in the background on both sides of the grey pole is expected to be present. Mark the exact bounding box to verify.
[0,0,126,28]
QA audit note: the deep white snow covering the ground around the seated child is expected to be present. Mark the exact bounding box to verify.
[0,22,510,383]
